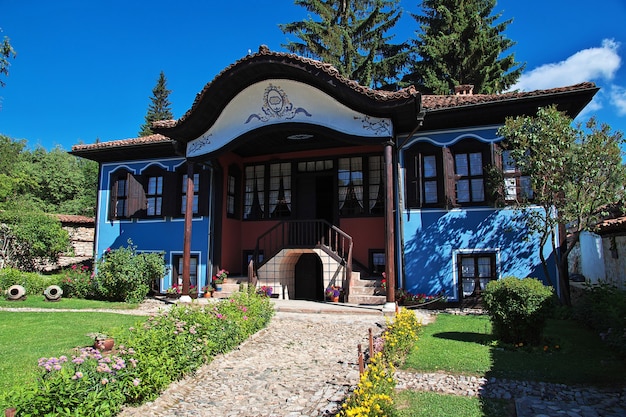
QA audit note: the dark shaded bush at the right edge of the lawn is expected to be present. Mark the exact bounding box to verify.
[574,282,626,355]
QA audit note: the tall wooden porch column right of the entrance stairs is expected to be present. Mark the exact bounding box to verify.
[385,141,396,304]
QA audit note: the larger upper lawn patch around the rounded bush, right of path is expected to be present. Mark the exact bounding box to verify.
[404,314,626,385]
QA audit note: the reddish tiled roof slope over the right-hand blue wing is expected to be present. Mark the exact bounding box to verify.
[422,82,596,111]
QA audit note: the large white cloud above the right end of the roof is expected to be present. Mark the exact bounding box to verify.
[511,39,626,91]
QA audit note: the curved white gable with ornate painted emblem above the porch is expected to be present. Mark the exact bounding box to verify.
[187,79,393,157]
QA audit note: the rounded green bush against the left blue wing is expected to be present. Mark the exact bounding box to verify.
[94,240,167,303]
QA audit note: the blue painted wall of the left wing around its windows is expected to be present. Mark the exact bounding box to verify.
[95,158,210,291]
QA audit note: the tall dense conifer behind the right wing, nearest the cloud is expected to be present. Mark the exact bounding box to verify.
[403,0,524,94]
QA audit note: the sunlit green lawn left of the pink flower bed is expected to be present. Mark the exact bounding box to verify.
[0,310,145,402]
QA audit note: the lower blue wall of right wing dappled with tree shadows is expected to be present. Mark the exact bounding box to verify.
[404,210,544,296]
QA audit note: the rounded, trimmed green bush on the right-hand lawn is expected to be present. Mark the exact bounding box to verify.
[483,277,554,345]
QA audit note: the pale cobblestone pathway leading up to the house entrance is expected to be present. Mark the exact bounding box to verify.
[120,312,385,417]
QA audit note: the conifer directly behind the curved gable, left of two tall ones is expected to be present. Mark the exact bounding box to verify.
[279,0,409,88]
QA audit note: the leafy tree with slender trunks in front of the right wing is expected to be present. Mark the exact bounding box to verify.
[498,106,626,304]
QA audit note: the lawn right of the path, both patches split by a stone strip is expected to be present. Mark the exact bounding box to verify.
[395,314,626,417]
